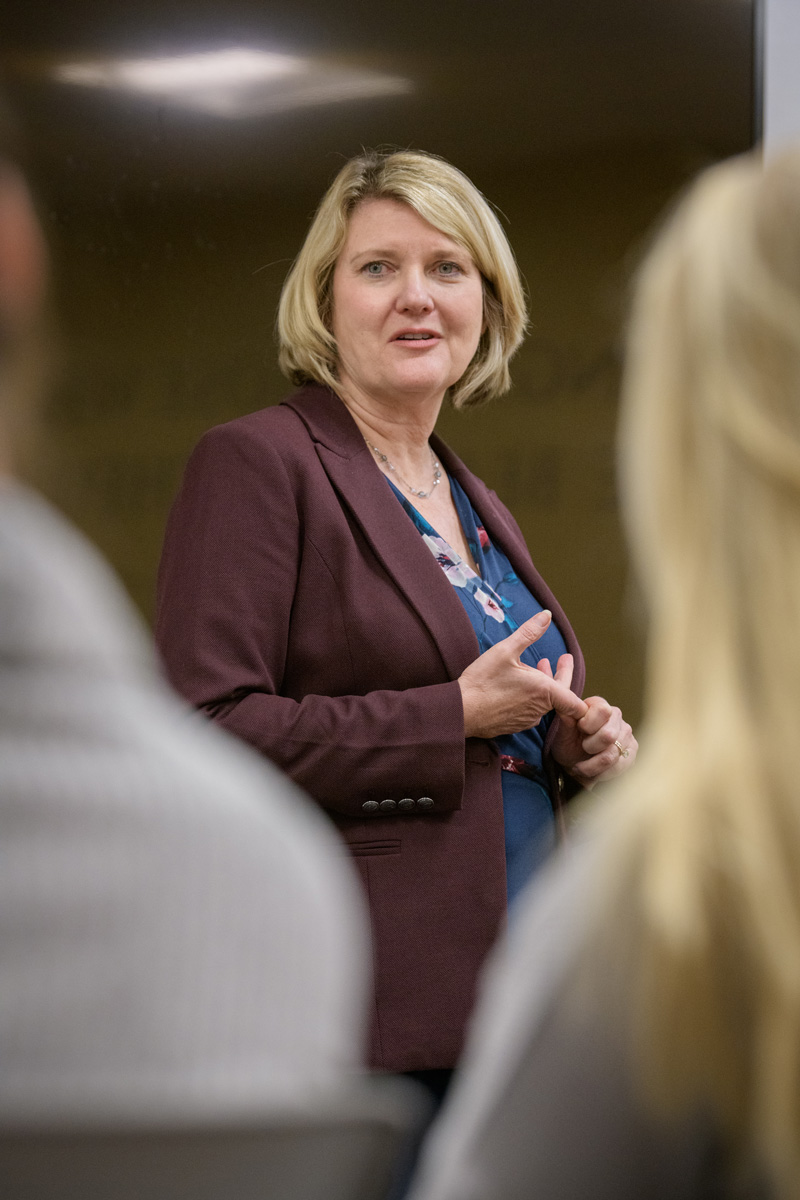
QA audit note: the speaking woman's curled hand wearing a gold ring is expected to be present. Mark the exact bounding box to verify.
[537,659,639,788]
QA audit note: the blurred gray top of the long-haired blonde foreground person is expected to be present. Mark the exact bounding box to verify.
[411,838,766,1200]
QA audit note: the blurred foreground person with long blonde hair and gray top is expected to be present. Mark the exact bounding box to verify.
[414,148,800,1200]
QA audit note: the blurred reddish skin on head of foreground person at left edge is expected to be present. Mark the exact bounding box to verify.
[0,167,47,338]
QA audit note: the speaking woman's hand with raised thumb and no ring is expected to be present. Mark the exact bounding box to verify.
[458,610,587,738]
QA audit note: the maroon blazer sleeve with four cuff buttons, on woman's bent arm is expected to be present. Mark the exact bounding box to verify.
[156,422,470,818]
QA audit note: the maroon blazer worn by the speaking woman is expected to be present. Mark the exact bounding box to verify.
[157,385,584,1070]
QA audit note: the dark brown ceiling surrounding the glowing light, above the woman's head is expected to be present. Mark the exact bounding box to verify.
[0,0,753,199]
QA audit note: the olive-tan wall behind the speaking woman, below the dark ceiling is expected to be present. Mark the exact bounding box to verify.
[34,140,714,718]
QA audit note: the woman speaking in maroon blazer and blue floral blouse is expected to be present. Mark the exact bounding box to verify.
[157,151,637,1082]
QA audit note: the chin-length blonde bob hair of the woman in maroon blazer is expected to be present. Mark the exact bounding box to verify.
[277,150,527,408]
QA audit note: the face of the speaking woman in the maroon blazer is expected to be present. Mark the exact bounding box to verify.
[333,199,483,415]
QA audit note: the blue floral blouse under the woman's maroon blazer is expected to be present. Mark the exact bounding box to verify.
[387,478,566,904]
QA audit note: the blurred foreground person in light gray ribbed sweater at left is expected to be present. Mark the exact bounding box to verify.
[0,114,367,1128]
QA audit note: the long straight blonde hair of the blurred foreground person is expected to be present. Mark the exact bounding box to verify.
[601,149,800,1196]
